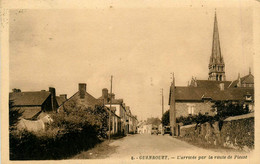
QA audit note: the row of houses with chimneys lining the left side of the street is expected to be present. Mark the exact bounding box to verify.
[9,83,138,134]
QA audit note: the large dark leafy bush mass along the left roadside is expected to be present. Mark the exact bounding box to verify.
[10,99,108,160]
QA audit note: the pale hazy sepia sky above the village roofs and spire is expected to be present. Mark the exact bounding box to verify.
[9,7,254,120]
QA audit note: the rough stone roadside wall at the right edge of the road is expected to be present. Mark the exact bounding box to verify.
[180,113,254,150]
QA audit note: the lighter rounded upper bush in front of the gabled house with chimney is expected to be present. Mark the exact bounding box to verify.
[52,101,108,138]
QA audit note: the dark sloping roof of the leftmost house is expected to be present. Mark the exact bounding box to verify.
[9,91,51,106]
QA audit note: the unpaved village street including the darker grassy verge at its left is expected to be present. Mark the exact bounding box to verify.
[75,134,248,159]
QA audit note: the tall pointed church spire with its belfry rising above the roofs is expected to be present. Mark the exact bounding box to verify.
[208,11,226,81]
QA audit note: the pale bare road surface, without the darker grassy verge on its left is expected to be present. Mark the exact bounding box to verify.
[109,134,232,159]
